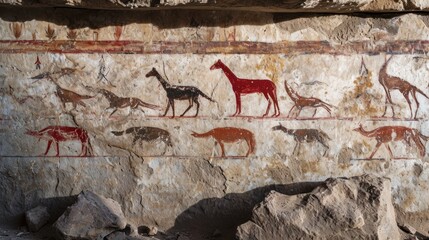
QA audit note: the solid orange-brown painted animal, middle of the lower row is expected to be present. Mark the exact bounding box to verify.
[191,127,256,157]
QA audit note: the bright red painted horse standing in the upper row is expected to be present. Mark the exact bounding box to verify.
[210,59,280,117]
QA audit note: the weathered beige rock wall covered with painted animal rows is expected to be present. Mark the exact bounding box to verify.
[0,8,429,229]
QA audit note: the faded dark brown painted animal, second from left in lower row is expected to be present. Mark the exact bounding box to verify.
[112,127,173,155]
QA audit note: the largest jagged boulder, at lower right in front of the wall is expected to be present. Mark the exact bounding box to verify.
[237,175,400,240]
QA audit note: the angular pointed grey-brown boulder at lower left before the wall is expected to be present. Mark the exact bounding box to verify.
[54,191,127,239]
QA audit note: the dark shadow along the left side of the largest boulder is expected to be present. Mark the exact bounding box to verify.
[167,182,324,240]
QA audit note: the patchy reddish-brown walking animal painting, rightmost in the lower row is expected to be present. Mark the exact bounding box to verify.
[353,125,429,159]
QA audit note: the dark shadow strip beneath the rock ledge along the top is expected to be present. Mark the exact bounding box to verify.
[0,6,420,32]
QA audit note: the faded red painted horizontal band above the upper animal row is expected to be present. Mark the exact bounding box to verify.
[0,40,429,55]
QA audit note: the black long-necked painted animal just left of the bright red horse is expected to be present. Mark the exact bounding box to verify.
[146,68,216,118]
